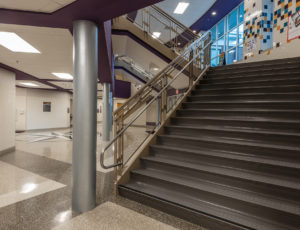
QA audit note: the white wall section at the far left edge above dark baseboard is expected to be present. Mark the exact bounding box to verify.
[0,69,16,151]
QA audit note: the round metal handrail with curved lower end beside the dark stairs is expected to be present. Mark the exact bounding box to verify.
[100,31,211,169]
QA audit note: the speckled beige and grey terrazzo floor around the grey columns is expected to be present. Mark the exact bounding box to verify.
[0,125,202,230]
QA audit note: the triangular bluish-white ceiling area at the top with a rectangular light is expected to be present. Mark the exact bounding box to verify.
[156,0,216,27]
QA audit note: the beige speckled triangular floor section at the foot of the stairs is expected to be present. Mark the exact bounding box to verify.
[54,202,180,230]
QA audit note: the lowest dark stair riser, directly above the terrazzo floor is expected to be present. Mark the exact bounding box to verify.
[119,187,248,230]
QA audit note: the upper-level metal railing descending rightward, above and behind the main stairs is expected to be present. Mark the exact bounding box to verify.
[127,5,200,54]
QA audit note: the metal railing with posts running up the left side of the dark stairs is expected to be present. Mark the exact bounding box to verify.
[100,32,211,181]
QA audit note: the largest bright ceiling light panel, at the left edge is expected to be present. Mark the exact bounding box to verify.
[0,32,40,53]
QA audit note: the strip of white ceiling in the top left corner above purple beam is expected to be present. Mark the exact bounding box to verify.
[0,0,76,13]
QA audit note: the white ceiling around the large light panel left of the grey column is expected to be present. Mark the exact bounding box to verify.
[0,24,73,82]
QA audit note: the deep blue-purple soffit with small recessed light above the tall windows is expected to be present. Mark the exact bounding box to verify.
[190,0,244,32]
